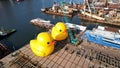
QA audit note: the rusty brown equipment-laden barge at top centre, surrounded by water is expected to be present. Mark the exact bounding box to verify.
[41,2,80,18]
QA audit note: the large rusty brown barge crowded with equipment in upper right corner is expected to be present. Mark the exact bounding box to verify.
[78,0,120,26]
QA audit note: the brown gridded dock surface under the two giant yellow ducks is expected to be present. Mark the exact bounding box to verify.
[0,41,120,68]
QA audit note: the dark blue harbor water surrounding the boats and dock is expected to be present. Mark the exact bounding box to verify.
[0,0,118,51]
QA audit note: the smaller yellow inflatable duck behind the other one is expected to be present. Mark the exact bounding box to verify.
[51,22,68,41]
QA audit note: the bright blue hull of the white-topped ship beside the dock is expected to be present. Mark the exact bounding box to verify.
[82,30,120,49]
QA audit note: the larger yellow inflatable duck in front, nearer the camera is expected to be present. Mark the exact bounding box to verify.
[30,32,54,57]
